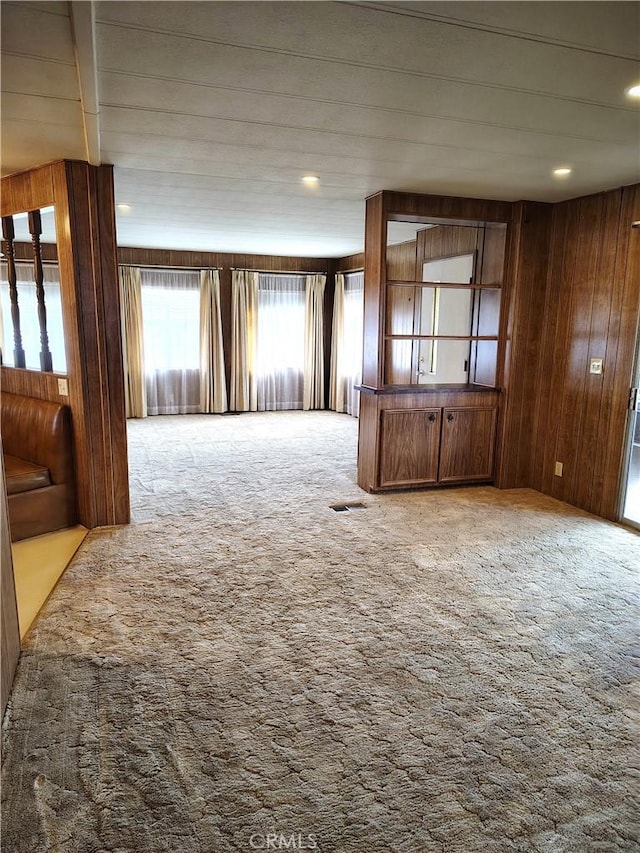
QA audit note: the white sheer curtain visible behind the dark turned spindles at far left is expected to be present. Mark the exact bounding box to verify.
[0,261,67,373]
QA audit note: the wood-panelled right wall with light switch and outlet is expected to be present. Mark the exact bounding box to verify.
[529,185,640,519]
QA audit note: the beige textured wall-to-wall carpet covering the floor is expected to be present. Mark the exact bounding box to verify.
[2,412,640,853]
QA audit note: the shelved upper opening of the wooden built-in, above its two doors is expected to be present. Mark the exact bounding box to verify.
[385,220,506,385]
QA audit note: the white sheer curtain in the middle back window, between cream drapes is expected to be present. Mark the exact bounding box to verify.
[256,273,305,411]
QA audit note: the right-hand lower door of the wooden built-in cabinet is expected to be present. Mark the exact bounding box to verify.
[439,407,496,483]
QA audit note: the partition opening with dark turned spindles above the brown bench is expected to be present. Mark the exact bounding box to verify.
[0,207,67,373]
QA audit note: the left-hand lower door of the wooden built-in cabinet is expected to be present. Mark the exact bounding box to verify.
[380,409,442,487]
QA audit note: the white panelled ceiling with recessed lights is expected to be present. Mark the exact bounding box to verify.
[1,0,640,257]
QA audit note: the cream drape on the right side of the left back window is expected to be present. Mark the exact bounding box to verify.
[200,269,227,414]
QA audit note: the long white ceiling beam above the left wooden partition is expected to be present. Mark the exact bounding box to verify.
[69,0,101,166]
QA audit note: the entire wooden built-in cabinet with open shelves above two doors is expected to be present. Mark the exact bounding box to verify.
[358,192,511,491]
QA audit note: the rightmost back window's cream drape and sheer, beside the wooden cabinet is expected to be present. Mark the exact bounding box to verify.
[330,271,364,417]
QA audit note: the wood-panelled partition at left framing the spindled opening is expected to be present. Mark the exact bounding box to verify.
[1,160,129,527]
